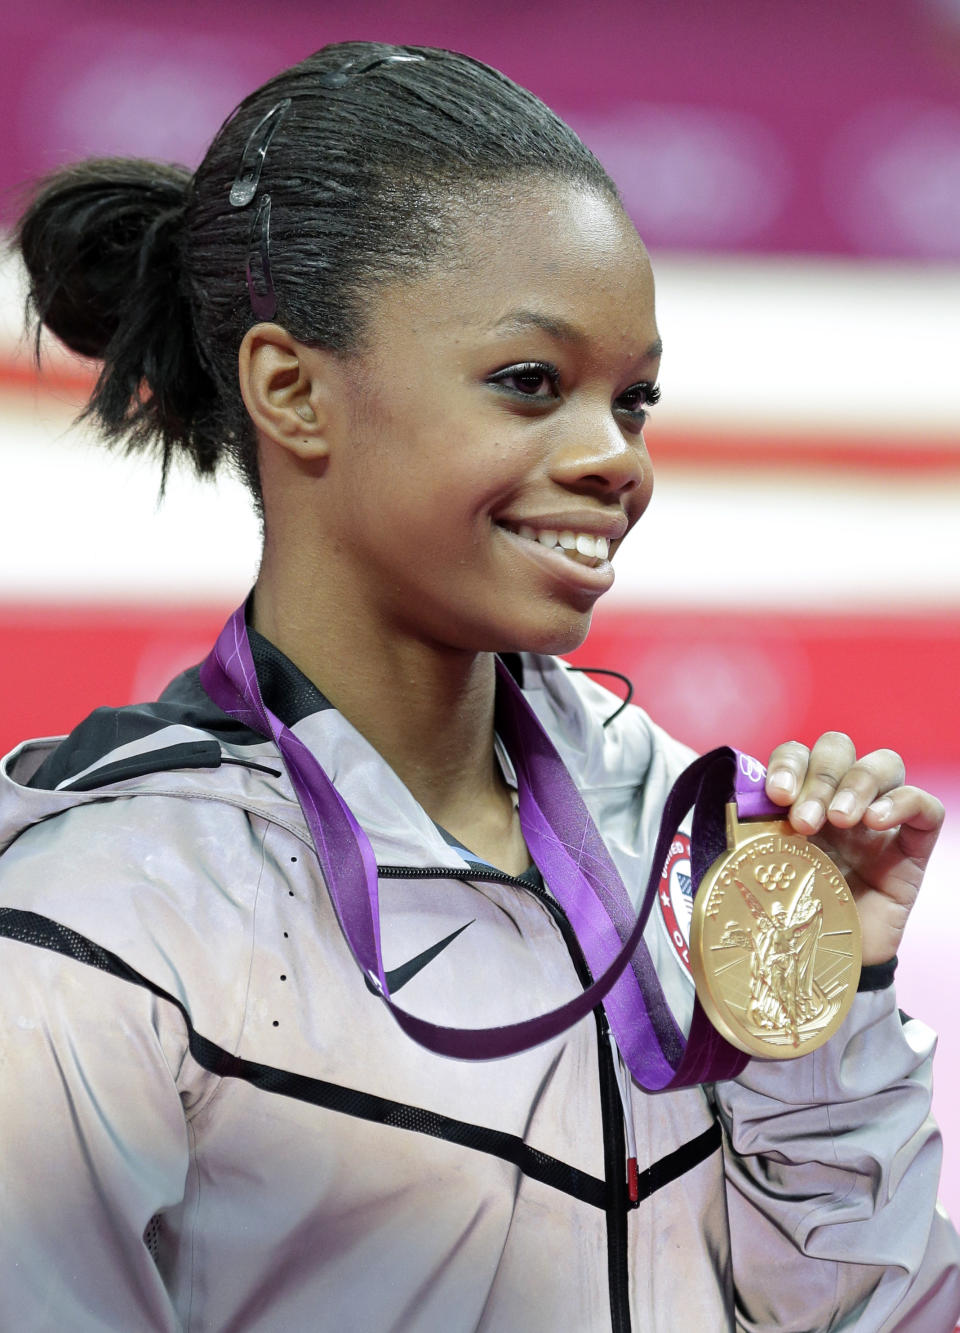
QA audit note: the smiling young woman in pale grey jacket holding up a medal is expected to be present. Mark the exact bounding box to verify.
[0,43,960,1333]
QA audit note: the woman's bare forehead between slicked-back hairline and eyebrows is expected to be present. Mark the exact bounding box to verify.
[369,183,657,355]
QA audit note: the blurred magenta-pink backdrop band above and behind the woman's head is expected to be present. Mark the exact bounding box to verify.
[0,0,960,259]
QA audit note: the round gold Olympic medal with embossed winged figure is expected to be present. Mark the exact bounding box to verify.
[691,802,860,1060]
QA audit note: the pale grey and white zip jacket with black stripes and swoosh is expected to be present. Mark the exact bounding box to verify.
[0,636,960,1333]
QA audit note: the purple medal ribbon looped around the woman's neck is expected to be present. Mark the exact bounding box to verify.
[200,607,780,1092]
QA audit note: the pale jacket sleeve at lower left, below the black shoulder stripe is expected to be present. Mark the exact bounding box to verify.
[0,938,188,1333]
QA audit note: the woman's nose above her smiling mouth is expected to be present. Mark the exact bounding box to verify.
[551,407,653,500]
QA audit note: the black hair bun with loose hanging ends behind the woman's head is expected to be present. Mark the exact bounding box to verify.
[16,157,219,491]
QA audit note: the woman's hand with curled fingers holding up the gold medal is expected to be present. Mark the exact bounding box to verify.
[767,732,944,966]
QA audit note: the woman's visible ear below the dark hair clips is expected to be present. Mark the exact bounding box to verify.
[237,324,331,461]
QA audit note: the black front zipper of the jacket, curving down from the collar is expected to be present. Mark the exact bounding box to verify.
[377,865,637,1333]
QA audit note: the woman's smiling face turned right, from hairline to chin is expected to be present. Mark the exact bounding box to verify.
[301,183,660,652]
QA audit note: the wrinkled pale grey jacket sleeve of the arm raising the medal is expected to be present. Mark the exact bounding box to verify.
[713,988,960,1333]
